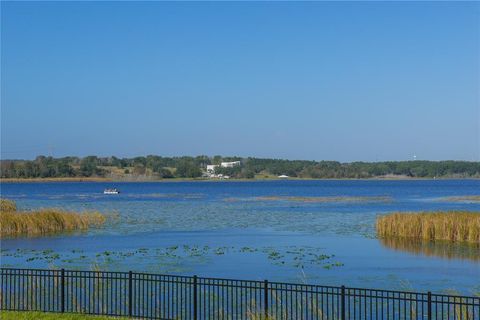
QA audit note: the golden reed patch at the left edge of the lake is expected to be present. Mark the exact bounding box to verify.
[0,199,105,238]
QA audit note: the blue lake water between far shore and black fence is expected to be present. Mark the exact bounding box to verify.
[1,180,480,294]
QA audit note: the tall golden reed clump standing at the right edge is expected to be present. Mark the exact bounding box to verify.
[376,211,480,244]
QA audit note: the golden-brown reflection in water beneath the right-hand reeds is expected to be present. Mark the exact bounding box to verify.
[379,237,480,261]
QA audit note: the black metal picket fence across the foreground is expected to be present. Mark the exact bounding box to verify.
[0,268,480,320]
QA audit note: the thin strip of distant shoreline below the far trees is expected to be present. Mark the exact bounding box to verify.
[0,176,480,184]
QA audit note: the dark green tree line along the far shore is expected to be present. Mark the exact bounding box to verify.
[0,155,480,179]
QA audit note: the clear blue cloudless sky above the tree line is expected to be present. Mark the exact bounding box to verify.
[1,2,480,161]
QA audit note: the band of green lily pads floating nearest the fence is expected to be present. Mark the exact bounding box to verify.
[2,245,343,272]
